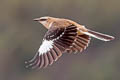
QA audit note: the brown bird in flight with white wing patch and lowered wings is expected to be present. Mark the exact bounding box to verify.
[25,16,114,69]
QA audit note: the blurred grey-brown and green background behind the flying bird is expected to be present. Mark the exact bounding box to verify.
[0,0,120,80]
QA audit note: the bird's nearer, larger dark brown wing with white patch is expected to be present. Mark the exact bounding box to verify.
[26,25,77,69]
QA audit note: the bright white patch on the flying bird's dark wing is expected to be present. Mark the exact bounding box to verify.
[38,40,53,56]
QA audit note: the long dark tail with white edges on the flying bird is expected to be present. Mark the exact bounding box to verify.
[83,30,114,41]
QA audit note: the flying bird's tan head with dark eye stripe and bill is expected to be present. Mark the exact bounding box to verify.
[34,16,56,29]
